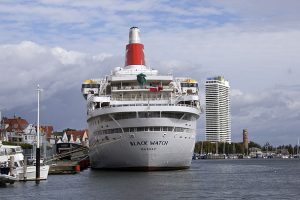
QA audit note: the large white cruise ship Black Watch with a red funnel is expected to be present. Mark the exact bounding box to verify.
[81,27,201,170]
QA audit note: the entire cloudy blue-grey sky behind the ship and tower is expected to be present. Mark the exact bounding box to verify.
[0,0,300,145]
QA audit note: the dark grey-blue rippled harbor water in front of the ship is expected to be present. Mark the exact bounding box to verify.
[0,159,300,200]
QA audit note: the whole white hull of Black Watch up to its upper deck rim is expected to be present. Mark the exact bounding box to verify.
[88,106,199,170]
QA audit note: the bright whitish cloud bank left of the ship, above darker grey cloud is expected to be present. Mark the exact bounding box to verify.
[0,41,113,109]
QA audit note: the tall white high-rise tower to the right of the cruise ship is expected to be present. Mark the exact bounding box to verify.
[205,76,231,143]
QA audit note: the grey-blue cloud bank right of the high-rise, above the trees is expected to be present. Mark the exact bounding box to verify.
[231,85,300,145]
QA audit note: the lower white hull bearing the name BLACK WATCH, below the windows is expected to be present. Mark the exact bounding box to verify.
[90,132,195,170]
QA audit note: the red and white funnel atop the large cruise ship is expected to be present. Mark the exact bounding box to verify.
[125,27,145,67]
